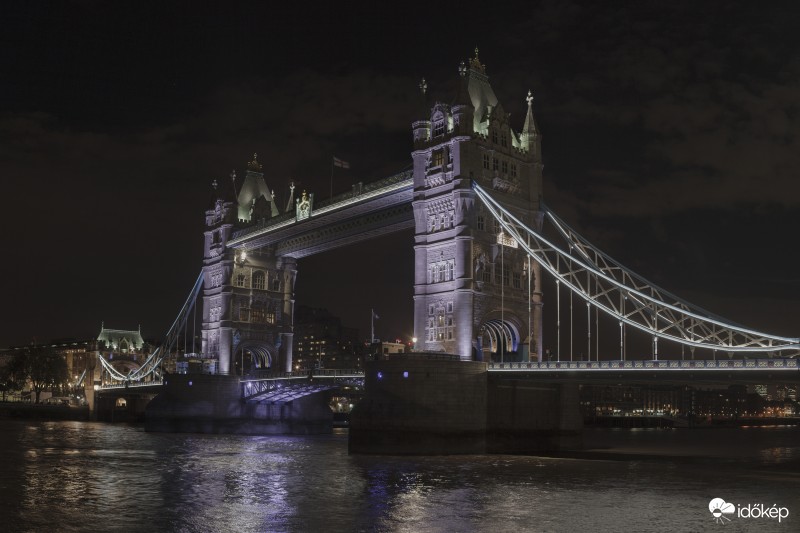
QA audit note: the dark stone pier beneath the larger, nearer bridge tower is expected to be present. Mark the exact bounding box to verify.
[349,354,583,455]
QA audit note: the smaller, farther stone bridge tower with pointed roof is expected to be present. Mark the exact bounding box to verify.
[201,155,297,374]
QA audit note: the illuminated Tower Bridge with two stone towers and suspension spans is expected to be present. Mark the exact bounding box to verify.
[92,52,800,444]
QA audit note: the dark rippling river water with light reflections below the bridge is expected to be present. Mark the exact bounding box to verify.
[0,420,800,533]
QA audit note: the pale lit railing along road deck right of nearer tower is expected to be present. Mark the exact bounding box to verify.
[489,359,800,371]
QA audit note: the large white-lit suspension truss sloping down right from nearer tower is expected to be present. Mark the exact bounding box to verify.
[472,182,800,357]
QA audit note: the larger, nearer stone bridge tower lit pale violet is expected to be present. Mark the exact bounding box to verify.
[412,49,542,361]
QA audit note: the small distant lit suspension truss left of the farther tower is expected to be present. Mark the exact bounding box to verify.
[97,272,203,387]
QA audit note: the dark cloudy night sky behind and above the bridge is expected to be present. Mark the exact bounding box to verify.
[0,0,800,347]
